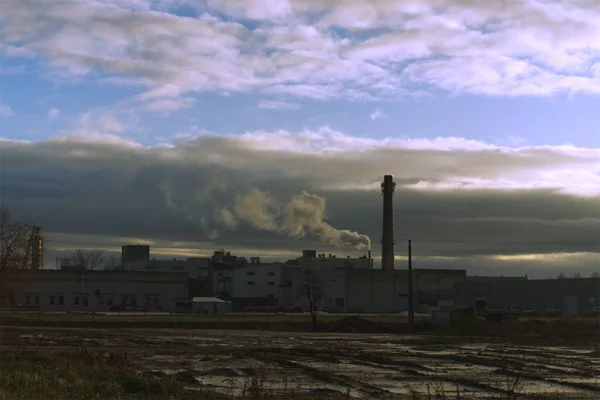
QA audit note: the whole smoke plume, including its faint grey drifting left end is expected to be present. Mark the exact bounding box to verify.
[158,171,371,249]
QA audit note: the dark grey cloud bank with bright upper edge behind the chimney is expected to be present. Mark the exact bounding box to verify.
[0,127,600,274]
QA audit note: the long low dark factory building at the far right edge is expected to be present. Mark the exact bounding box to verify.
[455,278,600,316]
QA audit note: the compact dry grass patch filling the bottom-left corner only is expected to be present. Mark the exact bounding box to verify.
[0,350,195,400]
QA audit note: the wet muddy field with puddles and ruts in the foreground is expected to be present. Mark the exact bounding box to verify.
[0,326,600,399]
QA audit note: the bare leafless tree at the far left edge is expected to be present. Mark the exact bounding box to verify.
[0,206,33,273]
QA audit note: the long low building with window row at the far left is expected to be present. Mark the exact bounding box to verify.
[0,270,189,311]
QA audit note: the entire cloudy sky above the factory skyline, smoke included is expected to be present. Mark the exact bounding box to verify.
[0,0,600,277]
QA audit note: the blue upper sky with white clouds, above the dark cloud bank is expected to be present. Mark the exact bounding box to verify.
[0,0,600,147]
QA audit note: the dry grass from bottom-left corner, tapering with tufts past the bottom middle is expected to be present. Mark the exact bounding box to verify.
[0,349,348,400]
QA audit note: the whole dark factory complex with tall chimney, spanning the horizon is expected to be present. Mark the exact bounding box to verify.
[0,175,600,315]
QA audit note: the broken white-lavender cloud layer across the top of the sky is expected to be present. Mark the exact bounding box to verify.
[0,0,600,99]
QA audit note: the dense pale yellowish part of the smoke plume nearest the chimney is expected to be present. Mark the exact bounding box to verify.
[234,188,371,249]
